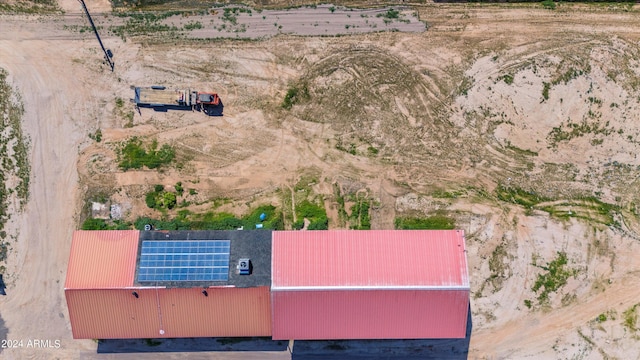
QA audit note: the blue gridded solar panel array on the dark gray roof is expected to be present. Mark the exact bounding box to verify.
[138,240,230,282]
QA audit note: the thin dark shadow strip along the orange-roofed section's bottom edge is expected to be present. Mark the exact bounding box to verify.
[98,337,289,354]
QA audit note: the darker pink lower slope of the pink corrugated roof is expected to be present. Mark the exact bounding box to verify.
[271,290,469,340]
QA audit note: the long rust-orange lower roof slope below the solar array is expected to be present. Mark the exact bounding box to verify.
[65,286,271,339]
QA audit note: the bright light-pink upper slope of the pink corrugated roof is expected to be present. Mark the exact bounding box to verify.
[272,230,469,291]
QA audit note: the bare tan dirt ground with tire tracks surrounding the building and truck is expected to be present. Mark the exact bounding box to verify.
[0,0,640,359]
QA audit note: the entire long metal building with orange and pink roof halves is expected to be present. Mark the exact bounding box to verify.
[65,230,469,340]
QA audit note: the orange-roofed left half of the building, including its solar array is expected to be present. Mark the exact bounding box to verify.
[65,231,271,339]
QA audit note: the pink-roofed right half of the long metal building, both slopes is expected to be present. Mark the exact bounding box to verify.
[271,230,469,340]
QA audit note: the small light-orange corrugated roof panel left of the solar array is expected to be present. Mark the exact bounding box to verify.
[65,230,140,289]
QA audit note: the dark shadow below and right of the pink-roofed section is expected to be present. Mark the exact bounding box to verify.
[291,307,473,360]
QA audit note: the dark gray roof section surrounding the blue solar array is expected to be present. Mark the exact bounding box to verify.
[135,230,271,287]
